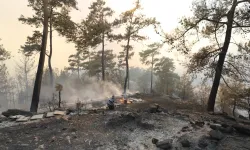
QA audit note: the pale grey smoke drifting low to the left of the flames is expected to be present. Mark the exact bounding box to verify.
[40,76,122,104]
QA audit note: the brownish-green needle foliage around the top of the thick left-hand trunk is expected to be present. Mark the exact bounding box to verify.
[18,0,77,55]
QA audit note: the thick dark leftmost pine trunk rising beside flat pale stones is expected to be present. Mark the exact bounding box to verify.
[30,0,48,112]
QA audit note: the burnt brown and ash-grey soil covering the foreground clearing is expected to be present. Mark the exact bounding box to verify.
[0,96,250,150]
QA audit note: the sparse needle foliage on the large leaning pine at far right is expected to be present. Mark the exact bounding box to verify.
[165,0,250,77]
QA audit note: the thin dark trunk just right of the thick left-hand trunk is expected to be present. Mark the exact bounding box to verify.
[48,8,54,89]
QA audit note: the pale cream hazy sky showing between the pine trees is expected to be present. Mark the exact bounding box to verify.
[0,0,192,74]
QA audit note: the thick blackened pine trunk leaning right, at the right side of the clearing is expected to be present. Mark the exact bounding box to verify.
[207,0,237,112]
